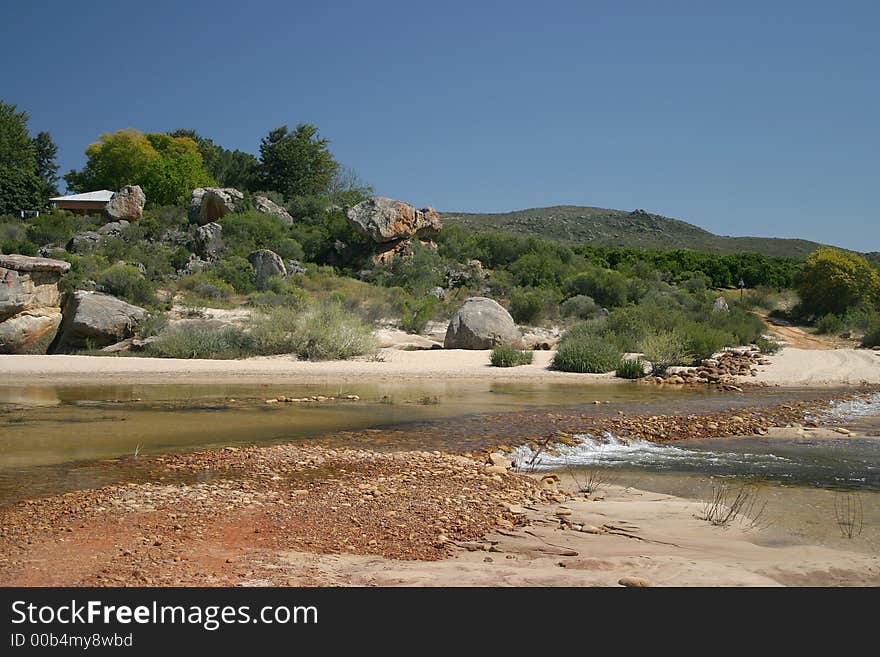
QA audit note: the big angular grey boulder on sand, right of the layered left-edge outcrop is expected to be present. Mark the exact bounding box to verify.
[51,290,149,352]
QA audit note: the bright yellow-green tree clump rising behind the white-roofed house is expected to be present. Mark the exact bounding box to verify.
[64,128,215,205]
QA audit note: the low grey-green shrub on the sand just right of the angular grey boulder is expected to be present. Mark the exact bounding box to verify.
[147,326,255,358]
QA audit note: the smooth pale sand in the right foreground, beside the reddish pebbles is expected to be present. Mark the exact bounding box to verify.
[280,480,880,586]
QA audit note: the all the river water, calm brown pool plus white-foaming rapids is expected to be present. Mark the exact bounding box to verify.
[0,381,880,553]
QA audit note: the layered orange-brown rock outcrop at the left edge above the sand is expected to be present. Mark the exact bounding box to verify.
[0,255,70,354]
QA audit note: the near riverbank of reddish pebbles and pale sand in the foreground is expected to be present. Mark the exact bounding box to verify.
[0,430,880,586]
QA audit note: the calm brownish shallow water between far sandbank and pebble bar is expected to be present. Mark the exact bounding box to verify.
[0,381,868,504]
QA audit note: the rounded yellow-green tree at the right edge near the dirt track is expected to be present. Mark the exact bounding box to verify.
[797,247,880,316]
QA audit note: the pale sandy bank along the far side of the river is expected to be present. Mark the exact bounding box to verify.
[0,348,880,387]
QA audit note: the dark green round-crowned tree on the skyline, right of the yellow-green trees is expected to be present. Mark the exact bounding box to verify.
[260,123,339,199]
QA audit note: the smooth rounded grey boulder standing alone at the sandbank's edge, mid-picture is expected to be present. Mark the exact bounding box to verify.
[443,297,522,349]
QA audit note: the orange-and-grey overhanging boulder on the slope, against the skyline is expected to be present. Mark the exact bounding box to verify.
[345,196,443,243]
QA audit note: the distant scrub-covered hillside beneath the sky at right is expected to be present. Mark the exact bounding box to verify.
[442,205,821,258]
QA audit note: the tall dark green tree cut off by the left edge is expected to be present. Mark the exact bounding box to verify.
[0,101,45,214]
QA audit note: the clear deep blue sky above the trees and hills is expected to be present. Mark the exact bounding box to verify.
[0,0,880,251]
